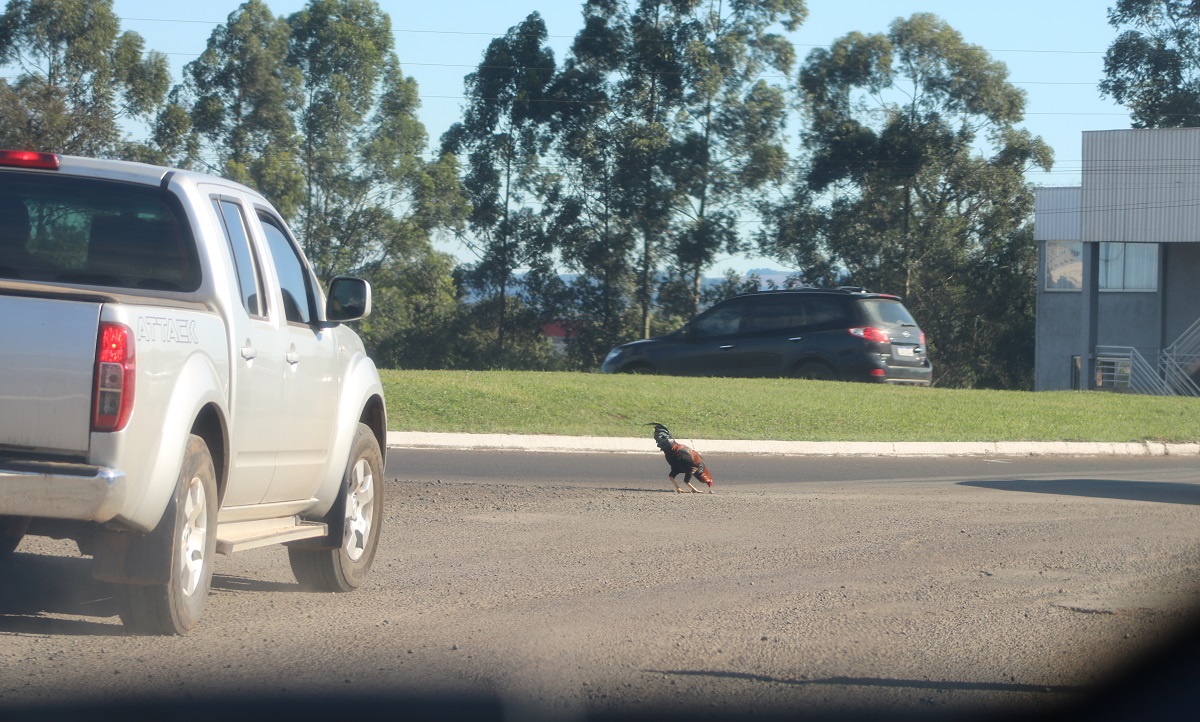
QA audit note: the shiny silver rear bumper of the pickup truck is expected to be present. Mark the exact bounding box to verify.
[0,461,128,522]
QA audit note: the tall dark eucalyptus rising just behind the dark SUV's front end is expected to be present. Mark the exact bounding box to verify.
[551,0,695,339]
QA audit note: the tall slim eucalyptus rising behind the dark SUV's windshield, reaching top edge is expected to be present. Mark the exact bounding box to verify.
[668,0,808,314]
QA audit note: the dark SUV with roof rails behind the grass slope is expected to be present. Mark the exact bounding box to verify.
[600,288,934,386]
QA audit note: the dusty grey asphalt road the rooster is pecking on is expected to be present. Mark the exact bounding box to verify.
[0,450,1200,720]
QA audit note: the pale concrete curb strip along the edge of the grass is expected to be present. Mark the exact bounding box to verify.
[388,432,1200,456]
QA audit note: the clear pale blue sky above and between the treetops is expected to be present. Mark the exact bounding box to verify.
[113,0,1129,272]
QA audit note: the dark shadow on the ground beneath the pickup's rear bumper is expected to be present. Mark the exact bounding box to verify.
[0,552,125,636]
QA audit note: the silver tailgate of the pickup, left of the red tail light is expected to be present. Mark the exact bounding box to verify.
[0,296,101,456]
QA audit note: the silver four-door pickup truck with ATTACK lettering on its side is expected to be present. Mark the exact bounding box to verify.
[0,151,386,634]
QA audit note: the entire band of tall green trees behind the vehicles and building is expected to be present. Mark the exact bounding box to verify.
[0,0,1056,387]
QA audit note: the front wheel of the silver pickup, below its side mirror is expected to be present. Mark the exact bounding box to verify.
[288,423,383,591]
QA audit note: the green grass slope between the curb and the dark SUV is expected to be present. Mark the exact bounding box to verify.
[380,369,1200,443]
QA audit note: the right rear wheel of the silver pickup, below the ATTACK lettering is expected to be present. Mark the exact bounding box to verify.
[121,435,217,634]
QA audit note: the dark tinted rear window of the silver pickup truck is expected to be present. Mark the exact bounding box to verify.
[0,173,200,291]
